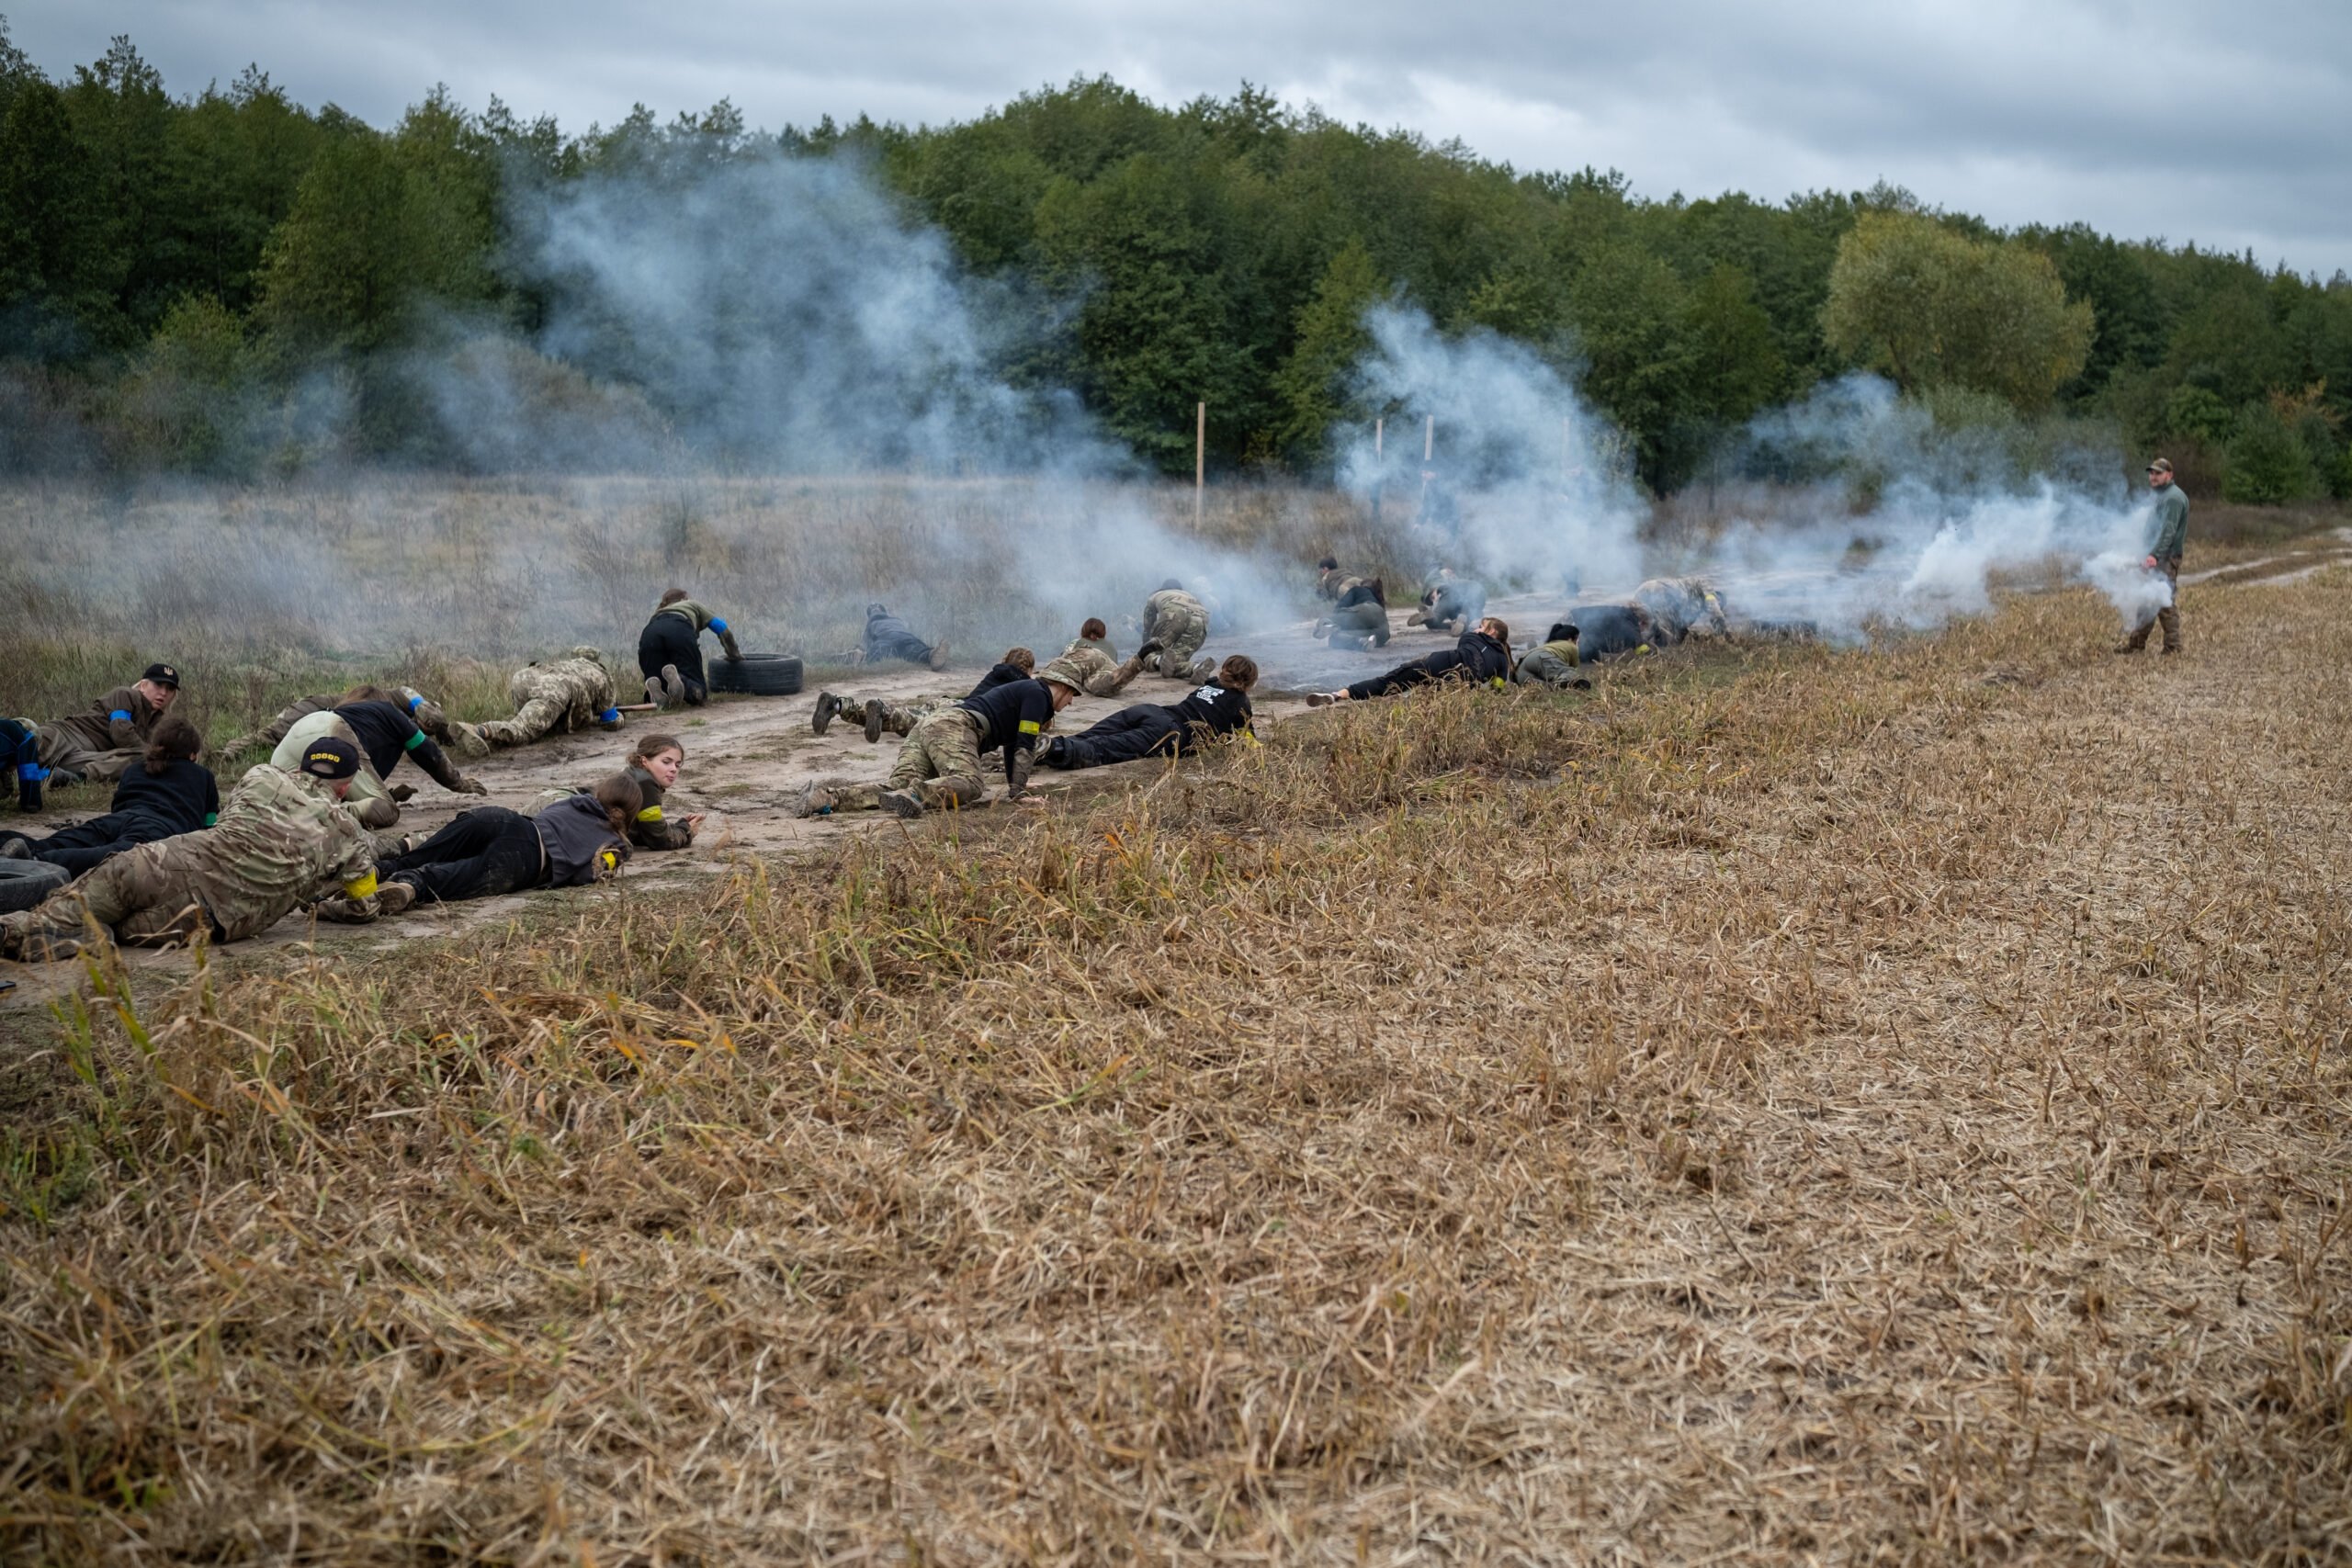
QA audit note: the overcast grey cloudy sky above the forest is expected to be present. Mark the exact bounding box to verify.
[18,0,2352,275]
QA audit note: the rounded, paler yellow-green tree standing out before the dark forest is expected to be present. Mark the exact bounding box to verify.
[1820,211,2091,412]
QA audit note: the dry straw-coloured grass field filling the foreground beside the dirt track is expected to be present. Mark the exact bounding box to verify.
[0,536,2352,1563]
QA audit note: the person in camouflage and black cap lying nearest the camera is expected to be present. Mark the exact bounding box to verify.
[0,736,383,962]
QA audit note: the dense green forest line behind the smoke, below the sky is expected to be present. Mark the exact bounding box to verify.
[0,24,2352,501]
